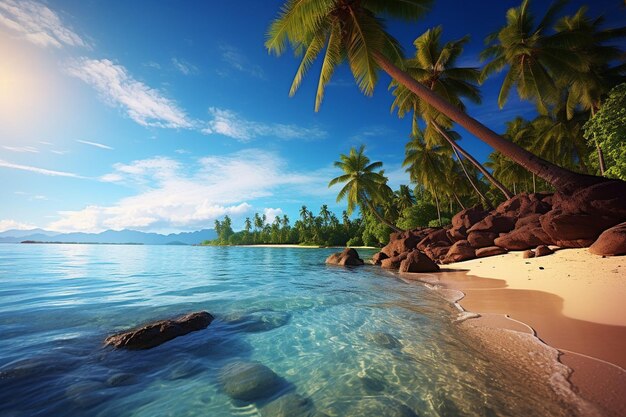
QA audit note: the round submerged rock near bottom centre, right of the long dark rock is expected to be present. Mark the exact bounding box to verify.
[218,361,283,402]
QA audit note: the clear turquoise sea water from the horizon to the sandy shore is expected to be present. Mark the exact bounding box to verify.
[0,245,570,417]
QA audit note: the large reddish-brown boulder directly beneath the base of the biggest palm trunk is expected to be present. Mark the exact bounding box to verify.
[540,209,618,248]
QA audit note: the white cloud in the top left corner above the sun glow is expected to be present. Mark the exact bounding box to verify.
[0,0,89,48]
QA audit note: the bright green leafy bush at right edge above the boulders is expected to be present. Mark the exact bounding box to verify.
[584,83,626,180]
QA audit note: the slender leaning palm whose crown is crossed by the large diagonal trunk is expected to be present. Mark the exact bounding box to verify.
[389,26,511,201]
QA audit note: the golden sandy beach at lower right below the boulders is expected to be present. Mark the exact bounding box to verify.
[402,249,626,416]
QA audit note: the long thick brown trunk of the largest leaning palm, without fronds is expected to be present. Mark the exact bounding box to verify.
[374,51,604,193]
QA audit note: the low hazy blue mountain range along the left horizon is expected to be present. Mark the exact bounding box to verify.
[0,229,217,245]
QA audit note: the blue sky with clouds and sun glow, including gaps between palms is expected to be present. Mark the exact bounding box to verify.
[0,0,626,232]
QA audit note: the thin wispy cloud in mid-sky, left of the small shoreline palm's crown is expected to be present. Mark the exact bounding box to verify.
[202,107,327,142]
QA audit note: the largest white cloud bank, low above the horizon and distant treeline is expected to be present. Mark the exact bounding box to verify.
[46,149,327,232]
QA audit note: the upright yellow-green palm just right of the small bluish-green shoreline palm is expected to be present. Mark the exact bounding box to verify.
[402,130,452,225]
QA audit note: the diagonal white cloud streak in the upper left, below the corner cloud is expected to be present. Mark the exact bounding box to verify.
[66,58,194,129]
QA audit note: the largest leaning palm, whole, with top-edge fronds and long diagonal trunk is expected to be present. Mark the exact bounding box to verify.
[265,0,602,192]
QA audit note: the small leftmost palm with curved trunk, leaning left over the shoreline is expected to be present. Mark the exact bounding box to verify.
[328,145,402,232]
